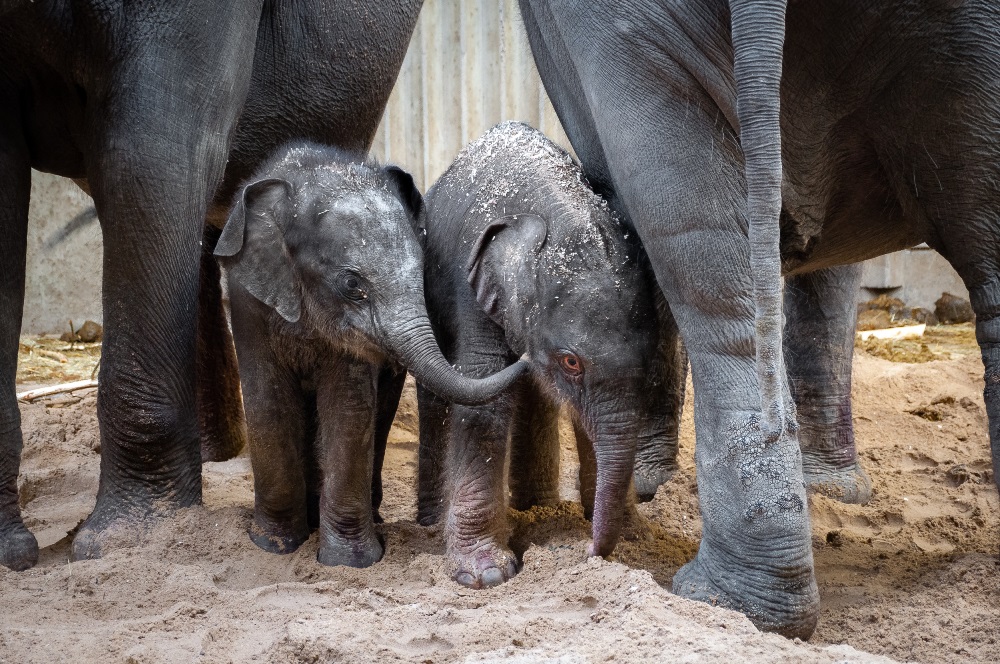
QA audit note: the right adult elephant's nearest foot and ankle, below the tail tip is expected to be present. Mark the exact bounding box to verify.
[673,413,819,639]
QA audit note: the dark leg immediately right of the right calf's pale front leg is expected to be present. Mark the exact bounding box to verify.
[510,381,559,510]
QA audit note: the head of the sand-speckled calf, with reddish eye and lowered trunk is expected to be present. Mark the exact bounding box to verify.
[466,206,656,555]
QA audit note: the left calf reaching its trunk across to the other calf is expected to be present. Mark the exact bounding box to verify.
[215,144,526,567]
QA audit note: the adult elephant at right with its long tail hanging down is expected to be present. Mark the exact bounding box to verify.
[520,0,1000,637]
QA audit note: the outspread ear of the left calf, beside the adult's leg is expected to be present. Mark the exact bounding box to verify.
[215,178,302,323]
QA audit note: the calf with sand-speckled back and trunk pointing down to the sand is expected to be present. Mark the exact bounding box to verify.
[418,123,663,588]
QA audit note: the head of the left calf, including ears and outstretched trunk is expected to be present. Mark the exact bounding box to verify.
[215,145,527,404]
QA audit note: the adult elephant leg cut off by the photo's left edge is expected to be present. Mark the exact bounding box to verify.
[0,107,38,570]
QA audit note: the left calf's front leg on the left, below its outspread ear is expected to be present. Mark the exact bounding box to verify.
[230,286,315,553]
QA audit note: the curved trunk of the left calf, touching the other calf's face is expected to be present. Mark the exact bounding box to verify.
[383,297,529,406]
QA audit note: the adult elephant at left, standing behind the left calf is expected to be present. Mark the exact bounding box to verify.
[0,0,421,569]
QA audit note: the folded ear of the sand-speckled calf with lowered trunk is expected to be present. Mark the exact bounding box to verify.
[465,214,549,326]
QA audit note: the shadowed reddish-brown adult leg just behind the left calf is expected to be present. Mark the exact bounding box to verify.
[195,226,247,462]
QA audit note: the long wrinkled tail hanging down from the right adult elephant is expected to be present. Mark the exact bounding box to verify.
[729,0,792,441]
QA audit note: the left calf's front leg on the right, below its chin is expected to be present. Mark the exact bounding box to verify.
[316,355,383,567]
